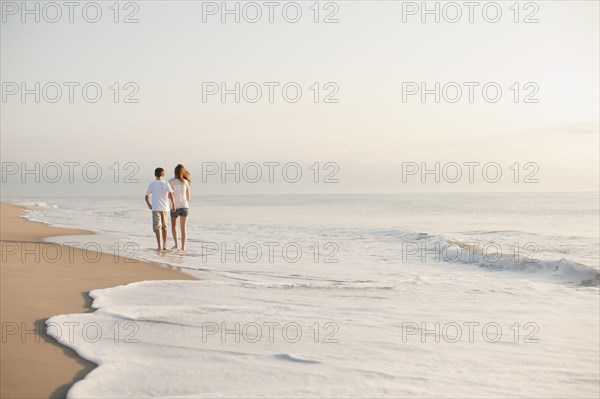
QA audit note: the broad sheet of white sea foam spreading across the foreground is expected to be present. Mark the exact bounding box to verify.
[48,276,599,398]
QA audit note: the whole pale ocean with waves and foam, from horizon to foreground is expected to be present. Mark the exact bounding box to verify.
[3,193,600,398]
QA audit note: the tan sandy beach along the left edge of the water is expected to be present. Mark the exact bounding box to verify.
[0,204,193,398]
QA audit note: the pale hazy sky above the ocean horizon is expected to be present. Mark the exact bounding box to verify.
[1,1,600,195]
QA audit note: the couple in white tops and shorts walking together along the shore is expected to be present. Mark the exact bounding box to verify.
[145,164,192,251]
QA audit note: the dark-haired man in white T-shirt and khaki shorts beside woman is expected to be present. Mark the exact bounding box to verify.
[146,168,175,251]
